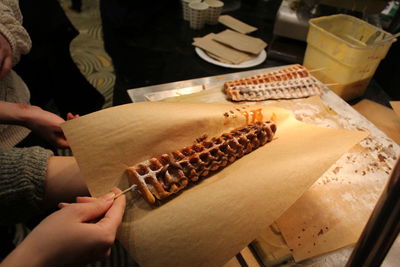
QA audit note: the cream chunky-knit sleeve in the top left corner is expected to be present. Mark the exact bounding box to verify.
[0,0,32,65]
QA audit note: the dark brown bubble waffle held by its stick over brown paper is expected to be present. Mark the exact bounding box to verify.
[126,121,276,204]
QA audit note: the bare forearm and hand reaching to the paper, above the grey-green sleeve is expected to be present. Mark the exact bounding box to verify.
[0,101,71,148]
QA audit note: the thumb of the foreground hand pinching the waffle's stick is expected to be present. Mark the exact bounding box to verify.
[72,198,113,222]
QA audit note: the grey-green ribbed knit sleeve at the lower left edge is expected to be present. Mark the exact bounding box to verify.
[0,147,52,225]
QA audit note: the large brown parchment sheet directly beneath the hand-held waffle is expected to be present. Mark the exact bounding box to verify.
[62,103,367,266]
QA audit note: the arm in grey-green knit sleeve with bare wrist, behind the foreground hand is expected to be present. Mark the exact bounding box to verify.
[0,147,89,224]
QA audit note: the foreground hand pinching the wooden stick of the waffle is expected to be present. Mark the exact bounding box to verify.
[3,189,125,266]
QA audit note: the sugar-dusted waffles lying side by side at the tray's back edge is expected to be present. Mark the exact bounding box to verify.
[224,65,321,101]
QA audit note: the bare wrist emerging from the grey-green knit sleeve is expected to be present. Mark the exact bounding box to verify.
[43,156,89,208]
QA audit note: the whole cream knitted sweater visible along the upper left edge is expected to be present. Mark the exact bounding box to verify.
[0,0,32,148]
